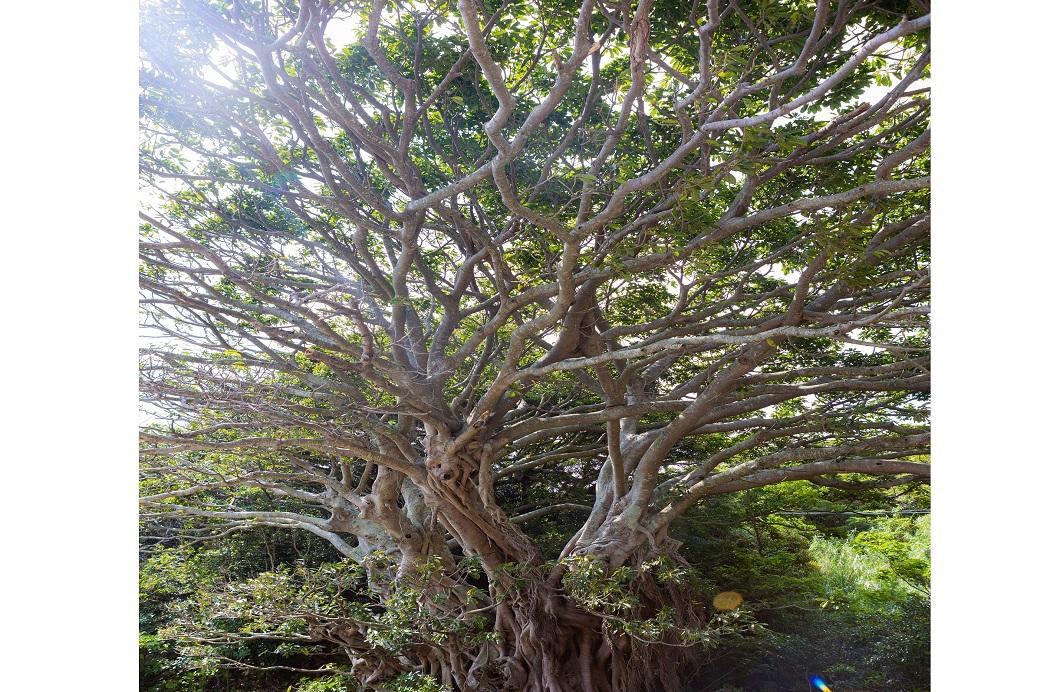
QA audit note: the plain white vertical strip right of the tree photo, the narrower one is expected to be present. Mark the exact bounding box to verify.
[932,2,1040,691]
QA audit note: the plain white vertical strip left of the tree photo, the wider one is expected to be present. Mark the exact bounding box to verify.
[0,0,137,692]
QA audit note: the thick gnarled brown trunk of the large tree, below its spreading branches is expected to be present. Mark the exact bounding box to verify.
[321,434,703,692]
